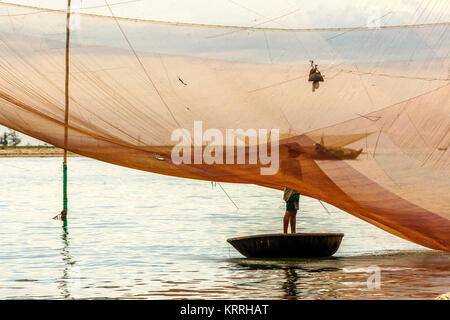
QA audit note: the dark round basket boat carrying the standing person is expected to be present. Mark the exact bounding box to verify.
[227,233,344,258]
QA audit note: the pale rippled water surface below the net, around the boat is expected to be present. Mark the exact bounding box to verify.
[0,158,450,299]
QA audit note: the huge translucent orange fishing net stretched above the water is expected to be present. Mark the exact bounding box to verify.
[0,4,450,250]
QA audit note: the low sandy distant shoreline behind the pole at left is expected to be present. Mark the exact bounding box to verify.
[0,146,81,158]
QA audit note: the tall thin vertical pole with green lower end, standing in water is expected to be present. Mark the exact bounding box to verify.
[61,0,71,221]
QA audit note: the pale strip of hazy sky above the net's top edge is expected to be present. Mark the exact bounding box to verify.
[0,0,450,28]
